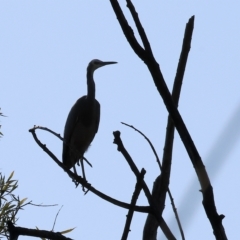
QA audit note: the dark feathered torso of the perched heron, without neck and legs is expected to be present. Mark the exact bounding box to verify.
[63,96,100,169]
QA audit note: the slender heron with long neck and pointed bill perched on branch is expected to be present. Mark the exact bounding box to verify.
[62,59,117,180]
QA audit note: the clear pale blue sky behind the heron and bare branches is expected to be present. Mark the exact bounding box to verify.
[0,0,240,240]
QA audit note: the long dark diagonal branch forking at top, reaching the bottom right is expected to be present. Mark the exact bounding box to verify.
[110,0,227,240]
